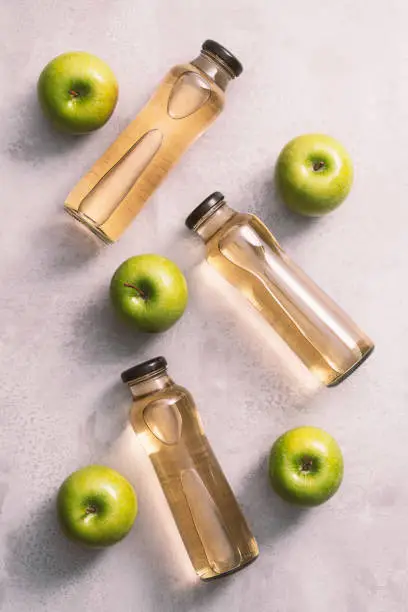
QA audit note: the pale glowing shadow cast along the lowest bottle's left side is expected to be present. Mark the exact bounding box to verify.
[107,425,233,612]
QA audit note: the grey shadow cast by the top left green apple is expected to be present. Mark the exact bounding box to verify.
[6,87,84,166]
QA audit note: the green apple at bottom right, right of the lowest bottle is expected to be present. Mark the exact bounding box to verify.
[269,427,343,506]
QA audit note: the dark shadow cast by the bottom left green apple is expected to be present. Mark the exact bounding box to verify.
[5,498,102,589]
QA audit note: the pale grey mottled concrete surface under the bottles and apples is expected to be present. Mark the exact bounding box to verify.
[0,0,408,612]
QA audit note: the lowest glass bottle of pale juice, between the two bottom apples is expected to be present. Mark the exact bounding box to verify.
[122,357,259,580]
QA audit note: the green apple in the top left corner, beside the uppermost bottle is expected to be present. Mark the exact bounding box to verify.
[37,51,118,134]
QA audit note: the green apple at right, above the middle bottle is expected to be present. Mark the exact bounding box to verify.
[276,134,353,217]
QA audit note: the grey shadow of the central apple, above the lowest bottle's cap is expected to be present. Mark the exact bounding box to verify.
[71,287,155,367]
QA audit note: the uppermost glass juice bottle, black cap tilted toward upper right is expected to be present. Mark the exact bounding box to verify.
[65,40,242,243]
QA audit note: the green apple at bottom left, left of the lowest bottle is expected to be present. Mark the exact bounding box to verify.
[57,465,137,547]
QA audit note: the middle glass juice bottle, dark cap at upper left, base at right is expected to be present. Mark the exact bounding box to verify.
[186,192,374,386]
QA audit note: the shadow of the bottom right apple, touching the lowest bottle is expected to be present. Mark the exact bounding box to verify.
[237,454,310,548]
